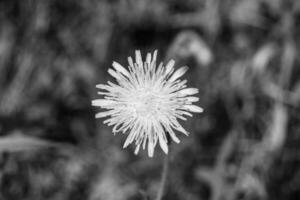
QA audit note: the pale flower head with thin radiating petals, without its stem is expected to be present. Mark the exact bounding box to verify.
[92,50,203,157]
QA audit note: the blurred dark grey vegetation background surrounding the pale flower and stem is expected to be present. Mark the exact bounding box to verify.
[0,0,300,200]
